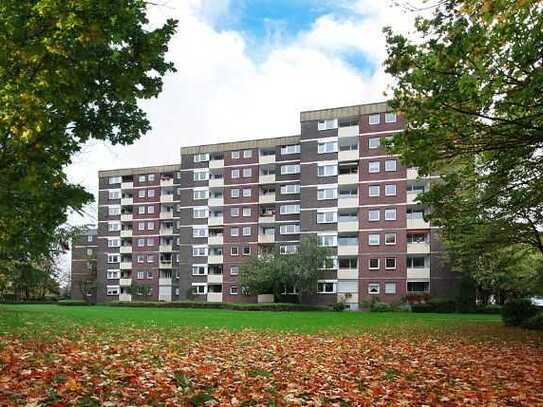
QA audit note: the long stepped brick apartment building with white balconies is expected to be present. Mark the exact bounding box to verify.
[75,103,457,309]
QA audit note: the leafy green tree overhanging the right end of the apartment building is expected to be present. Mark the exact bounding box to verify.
[385,0,543,270]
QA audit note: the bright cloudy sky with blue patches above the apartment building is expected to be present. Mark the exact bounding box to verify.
[61,0,423,276]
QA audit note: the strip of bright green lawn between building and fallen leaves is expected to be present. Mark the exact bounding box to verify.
[0,305,501,334]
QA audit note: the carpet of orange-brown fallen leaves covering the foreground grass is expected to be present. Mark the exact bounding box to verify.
[0,328,543,407]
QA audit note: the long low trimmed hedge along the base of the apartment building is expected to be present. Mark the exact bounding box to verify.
[104,301,331,311]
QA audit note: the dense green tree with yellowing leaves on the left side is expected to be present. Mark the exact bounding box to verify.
[0,0,176,271]
